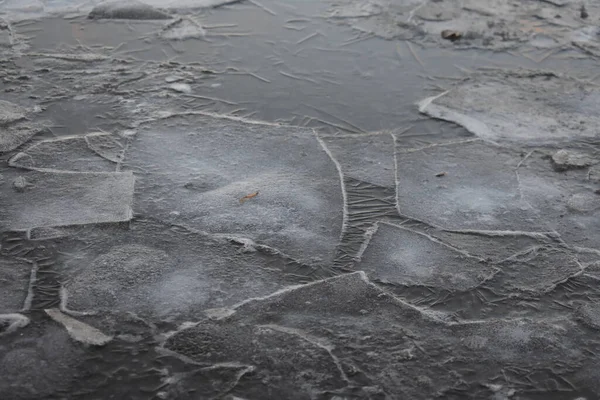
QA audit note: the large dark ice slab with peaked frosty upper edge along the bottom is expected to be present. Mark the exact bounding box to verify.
[165,272,599,399]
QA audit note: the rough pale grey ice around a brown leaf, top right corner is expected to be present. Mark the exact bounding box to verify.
[329,0,599,50]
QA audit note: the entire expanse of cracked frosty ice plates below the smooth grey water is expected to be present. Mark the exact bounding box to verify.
[0,0,600,400]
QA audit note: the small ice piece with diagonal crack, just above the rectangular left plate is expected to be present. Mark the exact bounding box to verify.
[9,133,124,172]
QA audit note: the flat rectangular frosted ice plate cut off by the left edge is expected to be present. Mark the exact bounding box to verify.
[0,171,134,230]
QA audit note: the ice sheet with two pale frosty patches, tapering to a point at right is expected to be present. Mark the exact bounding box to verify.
[50,220,322,320]
